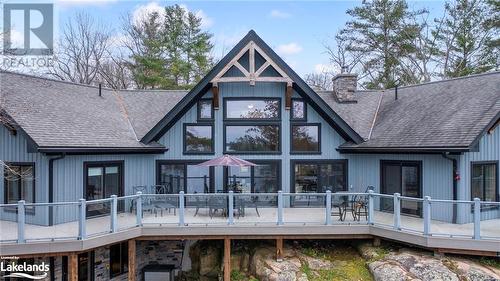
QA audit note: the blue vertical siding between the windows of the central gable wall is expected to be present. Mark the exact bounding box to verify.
[157,82,346,192]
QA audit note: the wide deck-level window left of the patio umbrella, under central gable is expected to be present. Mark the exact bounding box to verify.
[157,161,214,194]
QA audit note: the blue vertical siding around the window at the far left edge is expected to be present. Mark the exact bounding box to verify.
[0,125,49,225]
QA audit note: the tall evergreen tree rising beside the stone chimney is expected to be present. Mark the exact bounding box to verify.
[340,0,425,89]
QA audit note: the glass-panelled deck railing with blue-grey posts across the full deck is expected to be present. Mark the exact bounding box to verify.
[0,191,500,243]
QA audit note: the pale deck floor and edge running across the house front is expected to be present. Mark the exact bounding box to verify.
[0,208,500,255]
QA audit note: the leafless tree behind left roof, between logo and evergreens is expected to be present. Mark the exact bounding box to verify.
[49,13,111,85]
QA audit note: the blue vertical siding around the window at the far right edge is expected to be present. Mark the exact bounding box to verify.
[458,127,500,223]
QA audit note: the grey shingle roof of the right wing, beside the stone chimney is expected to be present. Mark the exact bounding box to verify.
[328,72,500,152]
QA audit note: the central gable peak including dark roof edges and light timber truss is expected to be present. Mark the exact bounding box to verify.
[141,30,363,143]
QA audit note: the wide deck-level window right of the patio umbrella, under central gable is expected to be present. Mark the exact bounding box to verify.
[293,160,347,193]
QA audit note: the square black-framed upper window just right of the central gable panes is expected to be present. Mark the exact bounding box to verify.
[291,124,321,153]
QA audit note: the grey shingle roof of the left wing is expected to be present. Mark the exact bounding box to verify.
[0,72,185,153]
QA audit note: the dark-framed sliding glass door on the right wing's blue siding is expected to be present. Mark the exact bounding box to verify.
[381,161,422,216]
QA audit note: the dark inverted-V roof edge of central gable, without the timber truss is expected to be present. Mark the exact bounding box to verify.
[141,30,363,143]
